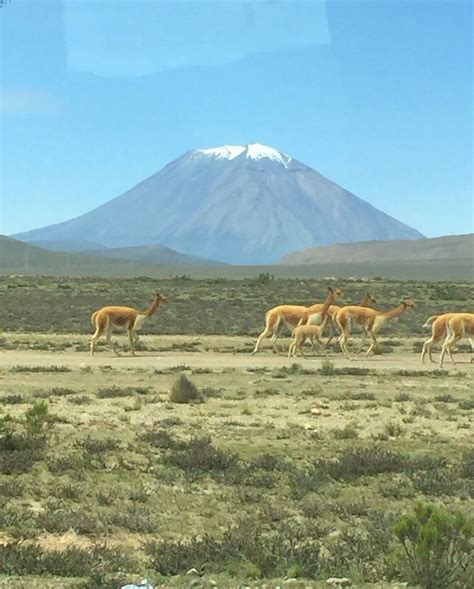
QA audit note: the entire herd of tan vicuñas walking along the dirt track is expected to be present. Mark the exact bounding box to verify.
[90,287,474,366]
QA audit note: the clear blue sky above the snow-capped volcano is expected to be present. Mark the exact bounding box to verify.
[0,0,473,239]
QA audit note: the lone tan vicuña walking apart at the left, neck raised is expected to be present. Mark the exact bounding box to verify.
[91,292,167,356]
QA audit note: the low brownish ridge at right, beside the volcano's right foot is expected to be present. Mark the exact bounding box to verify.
[279,233,474,266]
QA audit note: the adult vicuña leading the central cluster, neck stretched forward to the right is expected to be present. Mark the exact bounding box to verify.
[336,301,415,358]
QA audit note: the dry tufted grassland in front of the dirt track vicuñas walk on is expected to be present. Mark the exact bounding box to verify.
[0,340,474,588]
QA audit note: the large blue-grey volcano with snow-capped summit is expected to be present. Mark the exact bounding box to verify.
[13,143,422,264]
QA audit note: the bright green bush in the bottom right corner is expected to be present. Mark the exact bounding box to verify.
[394,503,474,589]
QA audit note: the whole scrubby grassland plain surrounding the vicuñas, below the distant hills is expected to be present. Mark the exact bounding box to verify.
[0,276,474,589]
